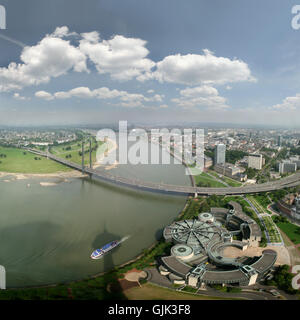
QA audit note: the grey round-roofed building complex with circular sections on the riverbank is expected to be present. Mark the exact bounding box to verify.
[158,202,277,288]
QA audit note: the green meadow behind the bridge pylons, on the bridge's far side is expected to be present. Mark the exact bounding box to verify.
[50,141,98,165]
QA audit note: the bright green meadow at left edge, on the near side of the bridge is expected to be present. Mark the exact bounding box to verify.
[0,147,70,174]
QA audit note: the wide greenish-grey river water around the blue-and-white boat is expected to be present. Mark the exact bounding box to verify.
[0,140,190,287]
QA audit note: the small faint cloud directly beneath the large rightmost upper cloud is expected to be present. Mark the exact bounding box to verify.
[172,85,229,109]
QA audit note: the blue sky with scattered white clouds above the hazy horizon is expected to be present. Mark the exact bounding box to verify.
[0,0,300,127]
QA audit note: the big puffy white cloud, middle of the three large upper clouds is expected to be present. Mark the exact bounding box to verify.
[79,32,155,80]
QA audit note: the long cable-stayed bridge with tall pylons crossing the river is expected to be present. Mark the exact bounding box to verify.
[26,146,300,196]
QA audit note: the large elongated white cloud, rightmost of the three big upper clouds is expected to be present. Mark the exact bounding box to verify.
[138,49,255,85]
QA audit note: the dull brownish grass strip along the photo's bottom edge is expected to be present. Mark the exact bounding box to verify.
[125,283,230,300]
